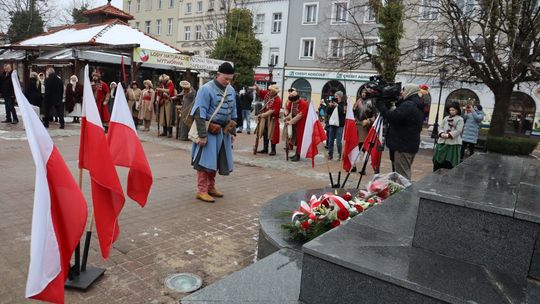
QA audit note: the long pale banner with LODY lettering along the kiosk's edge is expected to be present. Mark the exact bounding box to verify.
[133,48,232,71]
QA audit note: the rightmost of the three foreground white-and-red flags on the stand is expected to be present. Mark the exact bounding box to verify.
[107,84,152,207]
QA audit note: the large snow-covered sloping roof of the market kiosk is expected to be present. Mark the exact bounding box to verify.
[15,19,180,53]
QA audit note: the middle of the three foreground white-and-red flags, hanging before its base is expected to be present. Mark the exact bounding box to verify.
[79,65,125,259]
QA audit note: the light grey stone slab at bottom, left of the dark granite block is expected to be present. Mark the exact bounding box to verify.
[181,249,302,304]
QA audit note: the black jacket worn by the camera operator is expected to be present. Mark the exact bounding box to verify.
[376,94,424,154]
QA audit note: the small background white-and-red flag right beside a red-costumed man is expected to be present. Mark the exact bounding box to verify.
[300,103,326,167]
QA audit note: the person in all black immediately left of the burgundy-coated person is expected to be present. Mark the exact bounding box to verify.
[43,67,65,129]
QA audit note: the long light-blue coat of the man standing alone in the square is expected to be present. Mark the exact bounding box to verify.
[191,81,236,171]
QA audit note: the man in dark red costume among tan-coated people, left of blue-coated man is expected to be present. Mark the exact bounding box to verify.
[156,74,175,137]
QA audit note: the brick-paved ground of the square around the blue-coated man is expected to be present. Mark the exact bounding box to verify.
[0,107,532,303]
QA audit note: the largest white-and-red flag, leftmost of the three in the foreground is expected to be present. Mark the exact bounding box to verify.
[11,71,87,303]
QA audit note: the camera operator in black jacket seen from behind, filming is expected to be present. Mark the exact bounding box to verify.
[376,84,424,180]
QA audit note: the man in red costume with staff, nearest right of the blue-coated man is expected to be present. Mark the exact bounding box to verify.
[255,85,281,155]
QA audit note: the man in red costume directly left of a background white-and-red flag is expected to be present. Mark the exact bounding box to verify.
[285,88,309,161]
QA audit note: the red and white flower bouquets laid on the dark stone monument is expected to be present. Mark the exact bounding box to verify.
[282,172,411,242]
